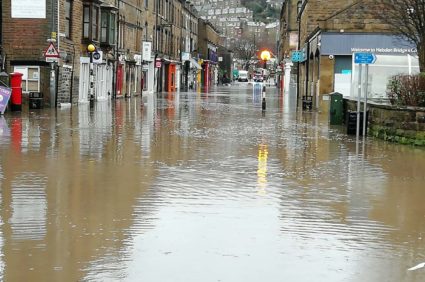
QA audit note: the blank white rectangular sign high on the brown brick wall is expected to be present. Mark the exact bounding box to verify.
[12,0,46,19]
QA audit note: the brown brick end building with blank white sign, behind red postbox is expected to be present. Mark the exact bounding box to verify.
[1,0,59,106]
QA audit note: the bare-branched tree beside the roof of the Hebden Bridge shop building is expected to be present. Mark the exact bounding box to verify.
[375,0,425,72]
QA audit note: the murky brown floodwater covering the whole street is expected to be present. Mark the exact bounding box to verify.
[0,86,425,282]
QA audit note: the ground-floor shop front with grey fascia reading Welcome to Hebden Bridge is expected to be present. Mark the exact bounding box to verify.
[300,32,419,108]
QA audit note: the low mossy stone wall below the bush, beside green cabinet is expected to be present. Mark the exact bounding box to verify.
[344,99,425,146]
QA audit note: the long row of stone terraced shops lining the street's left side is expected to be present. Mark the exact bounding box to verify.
[0,0,201,107]
